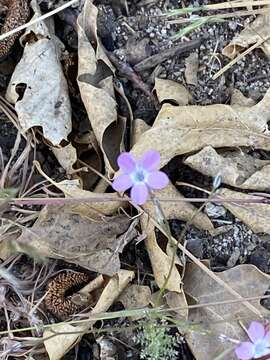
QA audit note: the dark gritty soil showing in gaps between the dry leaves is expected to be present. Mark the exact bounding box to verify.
[0,0,270,360]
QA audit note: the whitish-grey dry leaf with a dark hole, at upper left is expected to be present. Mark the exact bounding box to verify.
[6,0,71,146]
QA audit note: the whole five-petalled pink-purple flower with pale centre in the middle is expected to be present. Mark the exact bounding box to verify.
[112,150,169,205]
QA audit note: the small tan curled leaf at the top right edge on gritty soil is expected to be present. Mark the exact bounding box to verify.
[222,10,270,59]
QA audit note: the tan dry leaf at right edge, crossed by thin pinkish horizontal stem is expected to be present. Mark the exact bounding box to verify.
[218,189,270,234]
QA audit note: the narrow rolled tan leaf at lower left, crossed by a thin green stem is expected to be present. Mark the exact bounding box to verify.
[43,270,134,360]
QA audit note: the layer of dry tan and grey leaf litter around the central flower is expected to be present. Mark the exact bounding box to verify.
[0,0,270,360]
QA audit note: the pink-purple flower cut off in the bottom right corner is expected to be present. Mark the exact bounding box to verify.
[235,321,270,360]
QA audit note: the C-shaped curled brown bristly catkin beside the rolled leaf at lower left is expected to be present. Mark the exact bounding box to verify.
[45,272,90,320]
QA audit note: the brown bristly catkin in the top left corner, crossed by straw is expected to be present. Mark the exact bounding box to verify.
[0,0,30,58]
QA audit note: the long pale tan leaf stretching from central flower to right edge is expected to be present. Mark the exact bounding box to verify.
[127,86,270,167]
